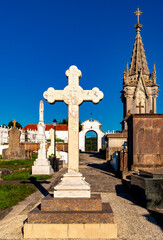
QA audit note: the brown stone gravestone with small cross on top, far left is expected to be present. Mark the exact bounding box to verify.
[2,119,26,160]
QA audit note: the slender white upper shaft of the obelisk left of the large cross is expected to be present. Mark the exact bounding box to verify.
[37,100,45,142]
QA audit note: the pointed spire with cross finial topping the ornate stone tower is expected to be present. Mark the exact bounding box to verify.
[129,8,150,76]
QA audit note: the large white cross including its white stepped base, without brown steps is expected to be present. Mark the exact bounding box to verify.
[43,66,103,198]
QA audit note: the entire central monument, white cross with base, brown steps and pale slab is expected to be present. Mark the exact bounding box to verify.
[24,66,117,239]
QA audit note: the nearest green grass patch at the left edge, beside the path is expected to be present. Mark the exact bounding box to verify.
[0,184,36,209]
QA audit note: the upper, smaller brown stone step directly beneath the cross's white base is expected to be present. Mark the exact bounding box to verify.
[41,194,102,212]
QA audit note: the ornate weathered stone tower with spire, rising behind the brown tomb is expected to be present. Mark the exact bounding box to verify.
[121,8,159,130]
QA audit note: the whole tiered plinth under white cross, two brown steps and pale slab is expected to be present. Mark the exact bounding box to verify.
[24,194,117,239]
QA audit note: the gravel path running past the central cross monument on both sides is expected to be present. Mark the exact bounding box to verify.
[0,153,163,240]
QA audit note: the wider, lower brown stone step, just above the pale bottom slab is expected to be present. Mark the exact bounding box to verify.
[28,203,114,224]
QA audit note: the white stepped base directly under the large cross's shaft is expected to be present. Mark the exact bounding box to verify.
[54,170,91,198]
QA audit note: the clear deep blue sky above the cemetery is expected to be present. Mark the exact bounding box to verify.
[0,0,163,131]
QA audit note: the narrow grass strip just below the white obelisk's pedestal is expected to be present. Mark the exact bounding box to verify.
[2,170,50,180]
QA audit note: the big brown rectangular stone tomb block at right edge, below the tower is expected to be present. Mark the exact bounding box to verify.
[127,114,163,170]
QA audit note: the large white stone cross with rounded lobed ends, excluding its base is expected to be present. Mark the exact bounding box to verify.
[43,66,104,172]
